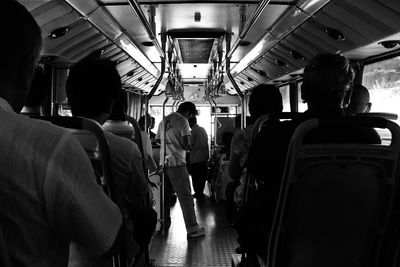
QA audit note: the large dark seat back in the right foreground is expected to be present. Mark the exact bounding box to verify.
[267,117,400,267]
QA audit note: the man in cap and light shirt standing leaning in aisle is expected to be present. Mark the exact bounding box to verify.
[156,102,205,239]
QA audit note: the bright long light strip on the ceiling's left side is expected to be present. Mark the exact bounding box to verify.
[116,34,160,77]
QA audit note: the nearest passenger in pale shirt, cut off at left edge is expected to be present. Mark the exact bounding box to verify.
[0,0,122,267]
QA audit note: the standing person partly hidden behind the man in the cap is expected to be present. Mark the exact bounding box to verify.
[189,117,209,199]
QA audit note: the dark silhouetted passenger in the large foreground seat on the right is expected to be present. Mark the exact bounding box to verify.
[248,53,381,262]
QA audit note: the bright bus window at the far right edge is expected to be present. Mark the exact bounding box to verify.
[362,56,400,114]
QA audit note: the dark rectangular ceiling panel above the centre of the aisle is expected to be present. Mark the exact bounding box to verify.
[178,39,214,63]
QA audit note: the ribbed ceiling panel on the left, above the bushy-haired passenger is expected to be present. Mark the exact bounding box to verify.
[19,0,159,93]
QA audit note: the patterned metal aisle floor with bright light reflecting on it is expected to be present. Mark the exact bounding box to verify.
[150,189,238,267]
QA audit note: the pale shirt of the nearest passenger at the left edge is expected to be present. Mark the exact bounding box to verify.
[0,98,122,267]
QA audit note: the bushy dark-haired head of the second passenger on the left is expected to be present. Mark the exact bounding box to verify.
[66,57,122,123]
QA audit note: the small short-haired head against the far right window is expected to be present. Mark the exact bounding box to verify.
[346,84,371,114]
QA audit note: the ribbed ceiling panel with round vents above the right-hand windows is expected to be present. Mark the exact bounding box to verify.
[243,0,400,87]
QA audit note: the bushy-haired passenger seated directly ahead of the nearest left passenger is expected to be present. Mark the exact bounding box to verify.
[66,58,157,255]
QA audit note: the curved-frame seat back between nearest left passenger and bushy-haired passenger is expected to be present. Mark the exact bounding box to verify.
[36,116,133,267]
